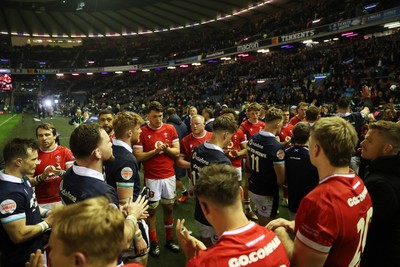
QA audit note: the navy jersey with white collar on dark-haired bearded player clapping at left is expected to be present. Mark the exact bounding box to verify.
[60,164,119,207]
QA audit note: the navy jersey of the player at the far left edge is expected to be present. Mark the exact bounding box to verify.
[0,170,43,267]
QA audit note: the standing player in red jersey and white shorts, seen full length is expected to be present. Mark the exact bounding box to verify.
[133,101,180,257]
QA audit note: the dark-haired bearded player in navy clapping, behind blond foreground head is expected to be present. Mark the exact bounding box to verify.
[60,123,148,263]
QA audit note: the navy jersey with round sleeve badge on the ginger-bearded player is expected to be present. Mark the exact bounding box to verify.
[105,139,140,201]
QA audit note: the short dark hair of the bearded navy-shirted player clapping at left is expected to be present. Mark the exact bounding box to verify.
[69,123,102,159]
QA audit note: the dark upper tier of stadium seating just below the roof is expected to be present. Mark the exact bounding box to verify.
[0,0,394,69]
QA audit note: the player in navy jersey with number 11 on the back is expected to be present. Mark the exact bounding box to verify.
[247,108,285,226]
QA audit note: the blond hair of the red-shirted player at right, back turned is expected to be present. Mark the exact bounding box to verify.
[311,116,358,167]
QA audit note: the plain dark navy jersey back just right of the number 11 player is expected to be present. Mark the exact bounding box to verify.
[285,145,319,213]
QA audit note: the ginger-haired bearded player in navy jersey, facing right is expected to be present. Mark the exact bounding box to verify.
[105,111,148,266]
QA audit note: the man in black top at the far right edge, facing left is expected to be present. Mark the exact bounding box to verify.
[361,121,400,267]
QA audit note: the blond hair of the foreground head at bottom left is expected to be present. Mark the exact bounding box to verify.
[52,197,126,267]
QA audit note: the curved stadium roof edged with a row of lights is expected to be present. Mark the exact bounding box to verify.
[0,0,307,37]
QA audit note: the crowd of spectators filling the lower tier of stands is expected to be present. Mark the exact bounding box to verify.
[33,30,400,121]
